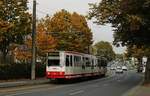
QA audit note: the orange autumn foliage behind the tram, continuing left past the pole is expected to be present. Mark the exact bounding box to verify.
[14,10,92,59]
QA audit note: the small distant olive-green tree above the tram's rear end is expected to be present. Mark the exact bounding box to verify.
[94,41,115,61]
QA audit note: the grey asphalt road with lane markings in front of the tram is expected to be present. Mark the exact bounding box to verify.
[0,71,142,96]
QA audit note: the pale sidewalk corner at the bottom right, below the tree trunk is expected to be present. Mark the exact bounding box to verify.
[125,85,150,96]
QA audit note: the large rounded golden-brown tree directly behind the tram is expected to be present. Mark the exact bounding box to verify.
[39,9,92,53]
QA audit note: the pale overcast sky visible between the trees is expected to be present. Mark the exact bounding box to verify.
[29,0,125,53]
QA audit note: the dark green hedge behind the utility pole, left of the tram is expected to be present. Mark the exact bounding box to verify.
[0,63,45,80]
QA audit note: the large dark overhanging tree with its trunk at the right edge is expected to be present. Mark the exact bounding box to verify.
[89,0,150,83]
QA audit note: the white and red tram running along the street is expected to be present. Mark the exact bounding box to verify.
[46,51,106,79]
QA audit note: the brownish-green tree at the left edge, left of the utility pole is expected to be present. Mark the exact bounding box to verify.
[0,0,31,63]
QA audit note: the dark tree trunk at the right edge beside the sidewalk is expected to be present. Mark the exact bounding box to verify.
[144,56,150,83]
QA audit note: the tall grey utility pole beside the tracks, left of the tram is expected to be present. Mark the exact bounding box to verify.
[31,0,36,80]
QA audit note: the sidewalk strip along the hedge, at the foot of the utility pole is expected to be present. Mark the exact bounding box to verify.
[0,78,49,88]
